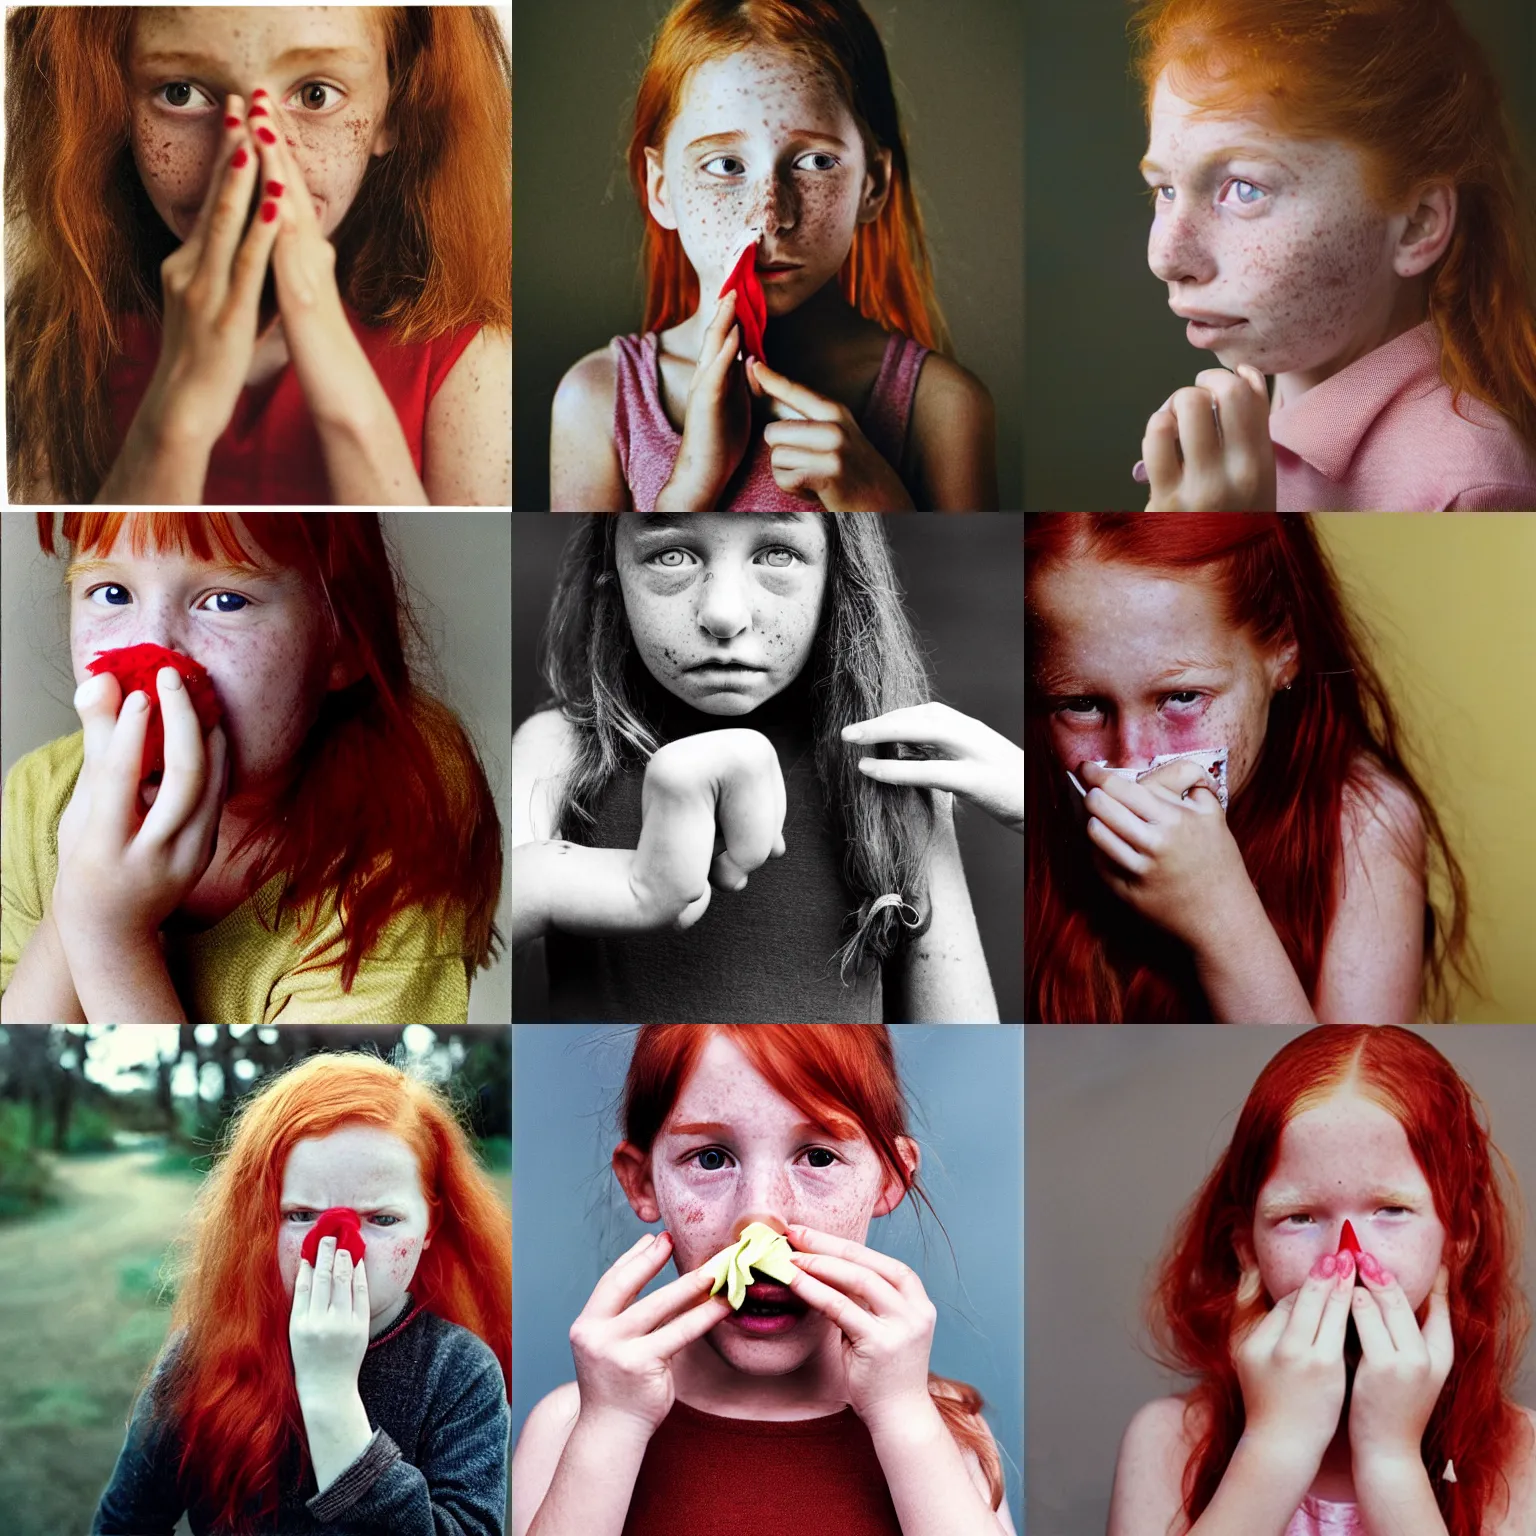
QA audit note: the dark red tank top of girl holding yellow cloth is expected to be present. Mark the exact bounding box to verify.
[624,1402,902,1536]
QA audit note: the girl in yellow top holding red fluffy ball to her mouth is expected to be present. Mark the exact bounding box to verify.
[0,511,502,1025]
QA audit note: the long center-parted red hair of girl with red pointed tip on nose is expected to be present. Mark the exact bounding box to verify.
[1149,1025,1530,1536]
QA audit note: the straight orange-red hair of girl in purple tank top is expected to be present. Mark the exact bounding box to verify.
[628,0,949,350]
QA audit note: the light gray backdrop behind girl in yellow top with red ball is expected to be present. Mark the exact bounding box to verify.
[0,511,511,1025]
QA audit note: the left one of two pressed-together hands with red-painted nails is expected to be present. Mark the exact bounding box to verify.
[140,95,285,447]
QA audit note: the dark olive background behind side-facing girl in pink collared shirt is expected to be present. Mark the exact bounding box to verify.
[1026,0,1536,511]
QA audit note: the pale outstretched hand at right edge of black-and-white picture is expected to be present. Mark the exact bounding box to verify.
[843,703,1025,833]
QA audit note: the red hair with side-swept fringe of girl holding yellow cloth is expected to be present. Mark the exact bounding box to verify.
[622,1025,1003,1510]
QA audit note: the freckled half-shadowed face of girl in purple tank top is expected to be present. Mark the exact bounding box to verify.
[645,46,889,316]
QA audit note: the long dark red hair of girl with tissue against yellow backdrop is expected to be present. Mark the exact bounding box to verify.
[1025,513,1470,1023]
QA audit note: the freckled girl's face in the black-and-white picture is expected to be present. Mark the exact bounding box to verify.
[614,511,828,714]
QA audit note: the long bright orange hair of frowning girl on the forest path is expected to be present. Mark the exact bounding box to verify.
[140,1052,511,1531]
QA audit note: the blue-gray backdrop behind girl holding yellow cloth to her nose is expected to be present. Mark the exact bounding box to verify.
[511,1025,1025,1531]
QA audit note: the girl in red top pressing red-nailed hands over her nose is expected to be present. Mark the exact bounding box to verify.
[6,6,511,505]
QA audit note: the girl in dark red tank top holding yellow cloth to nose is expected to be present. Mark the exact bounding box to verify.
[511,1025,1014,1536]
